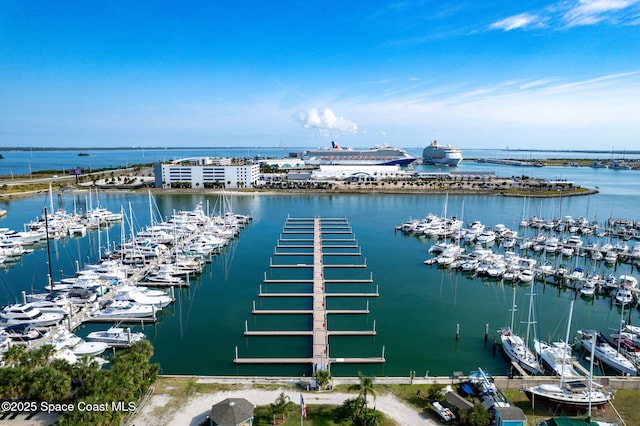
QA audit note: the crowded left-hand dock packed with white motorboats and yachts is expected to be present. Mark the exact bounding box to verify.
[0,194,255,370]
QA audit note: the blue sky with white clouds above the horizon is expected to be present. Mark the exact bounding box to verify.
[0,0,640,151]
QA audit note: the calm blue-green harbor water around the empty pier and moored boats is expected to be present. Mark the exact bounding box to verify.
[0,154,640,377]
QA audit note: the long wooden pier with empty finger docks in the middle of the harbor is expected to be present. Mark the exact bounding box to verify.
[234,218,385,371]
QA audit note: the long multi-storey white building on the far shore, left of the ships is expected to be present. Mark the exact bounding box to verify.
[154,160,260,188]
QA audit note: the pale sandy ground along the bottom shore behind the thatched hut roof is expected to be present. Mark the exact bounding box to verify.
[127,387,439,426]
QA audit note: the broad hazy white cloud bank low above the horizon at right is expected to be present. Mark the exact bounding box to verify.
[318,71,640,149]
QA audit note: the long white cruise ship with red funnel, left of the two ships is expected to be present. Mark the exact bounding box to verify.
[302,142,416,166]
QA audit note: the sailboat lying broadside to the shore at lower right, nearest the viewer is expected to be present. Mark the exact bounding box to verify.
[524,301,613,409]
